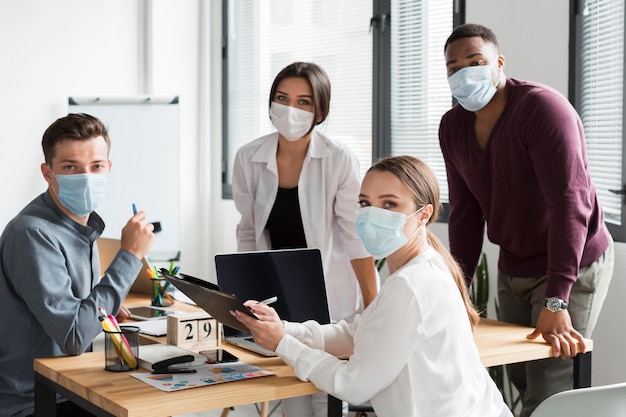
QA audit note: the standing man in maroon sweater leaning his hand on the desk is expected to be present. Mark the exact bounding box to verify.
[439,24,614,417]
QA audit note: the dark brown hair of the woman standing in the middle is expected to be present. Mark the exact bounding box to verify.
[269,62,330,124]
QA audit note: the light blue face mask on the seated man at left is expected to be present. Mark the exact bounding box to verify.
[56,174,109,217]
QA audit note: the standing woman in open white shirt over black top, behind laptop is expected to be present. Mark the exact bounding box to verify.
[233,62,378,417]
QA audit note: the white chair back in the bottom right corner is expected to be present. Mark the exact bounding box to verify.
[530,382,626,417]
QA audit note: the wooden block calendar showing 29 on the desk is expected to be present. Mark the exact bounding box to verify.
[167,311,222,351]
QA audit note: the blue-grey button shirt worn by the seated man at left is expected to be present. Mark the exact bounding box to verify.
[0,192,141,417]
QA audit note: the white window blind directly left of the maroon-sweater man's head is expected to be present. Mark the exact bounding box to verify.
[391,0,453,203]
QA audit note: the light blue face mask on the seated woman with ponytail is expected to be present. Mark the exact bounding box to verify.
[356,206,424,259]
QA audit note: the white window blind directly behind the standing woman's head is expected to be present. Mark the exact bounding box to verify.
[224,0,372,184]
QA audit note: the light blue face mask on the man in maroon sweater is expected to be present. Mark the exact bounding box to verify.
[448,65,497,111]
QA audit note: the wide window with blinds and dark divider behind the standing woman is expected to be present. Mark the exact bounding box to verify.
[222,0,454,201]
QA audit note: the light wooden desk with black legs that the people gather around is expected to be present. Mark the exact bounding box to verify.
[34,300,593,417]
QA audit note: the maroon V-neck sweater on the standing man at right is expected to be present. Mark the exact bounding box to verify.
[439,78,610,300]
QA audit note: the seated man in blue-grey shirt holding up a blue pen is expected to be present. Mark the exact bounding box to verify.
[0,114,154,417]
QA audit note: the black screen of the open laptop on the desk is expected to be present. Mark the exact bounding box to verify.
[215,248,330,336]
